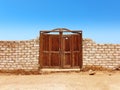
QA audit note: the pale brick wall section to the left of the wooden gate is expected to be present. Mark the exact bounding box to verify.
[0,39,39,70]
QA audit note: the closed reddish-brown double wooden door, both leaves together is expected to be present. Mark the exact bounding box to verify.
[40,33,82,68]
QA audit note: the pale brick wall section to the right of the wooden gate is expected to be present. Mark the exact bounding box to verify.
[83,39,120,68]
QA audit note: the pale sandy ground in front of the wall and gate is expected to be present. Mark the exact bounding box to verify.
[0,72,120,90]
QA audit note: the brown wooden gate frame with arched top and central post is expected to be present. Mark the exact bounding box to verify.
[39,28,83,68]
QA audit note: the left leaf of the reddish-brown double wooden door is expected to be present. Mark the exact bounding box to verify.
[40,34,60,67]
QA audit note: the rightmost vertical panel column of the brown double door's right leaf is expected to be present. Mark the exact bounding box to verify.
[71,34,82,68]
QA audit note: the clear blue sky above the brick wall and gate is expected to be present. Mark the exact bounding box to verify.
[0,0,120,43]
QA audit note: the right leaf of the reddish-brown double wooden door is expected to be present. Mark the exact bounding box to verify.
[62,34,82,68]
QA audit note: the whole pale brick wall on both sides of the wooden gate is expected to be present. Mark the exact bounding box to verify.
[0,39,120,70]
